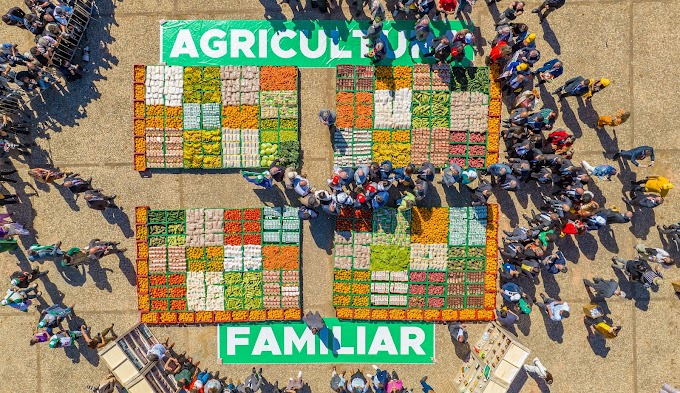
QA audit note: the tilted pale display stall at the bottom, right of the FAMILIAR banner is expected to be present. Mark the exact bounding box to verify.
[456,322,531,393]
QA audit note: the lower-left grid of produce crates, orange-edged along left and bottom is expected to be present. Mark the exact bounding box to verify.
[135,206,301,324]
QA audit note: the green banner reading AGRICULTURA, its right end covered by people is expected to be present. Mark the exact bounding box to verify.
[160,20,473,68]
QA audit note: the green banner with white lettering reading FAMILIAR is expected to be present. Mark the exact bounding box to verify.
[217,318,435,364]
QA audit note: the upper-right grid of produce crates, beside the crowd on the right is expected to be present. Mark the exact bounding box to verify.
[334,64,500,168]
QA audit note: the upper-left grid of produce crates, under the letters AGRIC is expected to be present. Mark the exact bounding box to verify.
[133,65,300,171]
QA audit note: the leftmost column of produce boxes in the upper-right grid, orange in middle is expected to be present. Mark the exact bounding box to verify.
[333,65,373,166]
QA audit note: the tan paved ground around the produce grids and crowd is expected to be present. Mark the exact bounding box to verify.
[0,0,680,393]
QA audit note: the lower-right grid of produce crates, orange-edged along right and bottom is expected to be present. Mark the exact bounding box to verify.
[333,205,498,321]
